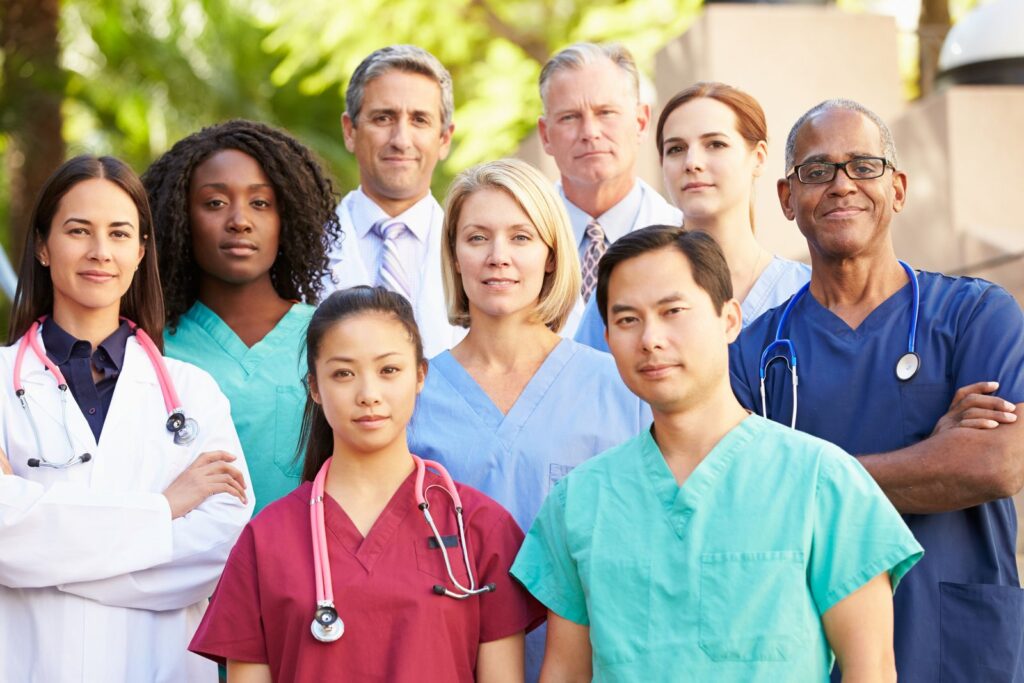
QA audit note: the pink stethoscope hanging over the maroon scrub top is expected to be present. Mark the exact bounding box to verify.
[309,456,497,643]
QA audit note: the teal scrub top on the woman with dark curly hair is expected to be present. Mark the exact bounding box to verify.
[164,301,315,512]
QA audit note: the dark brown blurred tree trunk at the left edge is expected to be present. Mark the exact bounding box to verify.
[0,0,66,269]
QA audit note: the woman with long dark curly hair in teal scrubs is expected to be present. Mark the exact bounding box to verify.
[142,121,339,511]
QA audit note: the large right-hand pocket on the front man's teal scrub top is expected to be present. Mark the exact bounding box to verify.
[699,550,810,661]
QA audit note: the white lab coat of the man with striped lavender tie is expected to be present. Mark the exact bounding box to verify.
[324,191,466,358]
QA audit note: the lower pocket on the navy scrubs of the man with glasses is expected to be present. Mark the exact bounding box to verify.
[939,582,1024,683]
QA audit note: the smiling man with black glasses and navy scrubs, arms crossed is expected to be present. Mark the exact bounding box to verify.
[730,100,1024,683]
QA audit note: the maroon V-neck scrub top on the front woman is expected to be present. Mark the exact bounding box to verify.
[189,471,545,682]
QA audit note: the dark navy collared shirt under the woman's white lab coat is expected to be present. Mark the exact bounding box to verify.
[43,317,131,441]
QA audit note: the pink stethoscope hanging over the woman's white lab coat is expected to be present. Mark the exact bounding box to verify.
[14,315,199,470]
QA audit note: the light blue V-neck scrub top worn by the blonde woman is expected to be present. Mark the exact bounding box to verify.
[408,339,651,681]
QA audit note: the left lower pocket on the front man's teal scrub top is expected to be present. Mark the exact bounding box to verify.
[584,548,655,667]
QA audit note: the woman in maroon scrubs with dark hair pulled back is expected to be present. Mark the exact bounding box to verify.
[190,287,543,683]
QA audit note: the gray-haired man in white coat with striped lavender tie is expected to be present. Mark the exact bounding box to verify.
[325,45,458,356]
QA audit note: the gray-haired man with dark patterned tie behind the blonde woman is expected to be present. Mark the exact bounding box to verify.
[538,43,683,335]
